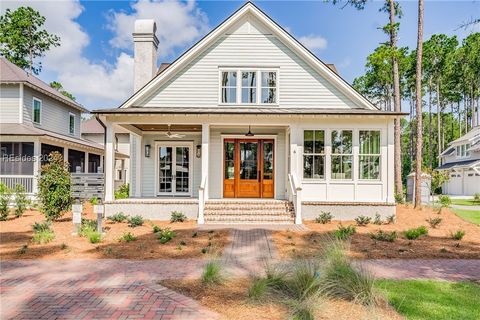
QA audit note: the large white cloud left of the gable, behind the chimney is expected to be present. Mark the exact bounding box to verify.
[0,0,206,109]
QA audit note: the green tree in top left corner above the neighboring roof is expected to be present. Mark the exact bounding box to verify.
[0,7,60,74]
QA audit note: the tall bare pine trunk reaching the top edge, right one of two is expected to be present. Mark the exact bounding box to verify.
[415,0,423,208]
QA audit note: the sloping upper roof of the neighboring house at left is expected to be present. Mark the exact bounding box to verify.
[0,56,88,112]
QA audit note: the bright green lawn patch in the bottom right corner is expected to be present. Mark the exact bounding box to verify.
[377,280,480,320]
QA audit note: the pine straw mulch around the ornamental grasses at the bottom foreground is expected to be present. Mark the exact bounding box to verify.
[159,278,402,320]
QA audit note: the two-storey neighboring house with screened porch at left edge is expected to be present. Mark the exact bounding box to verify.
[0,57,103,195]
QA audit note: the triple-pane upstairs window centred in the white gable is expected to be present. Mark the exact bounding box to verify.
[220,68,278,104]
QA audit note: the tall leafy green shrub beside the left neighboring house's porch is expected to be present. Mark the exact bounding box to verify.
[38,151,72,220]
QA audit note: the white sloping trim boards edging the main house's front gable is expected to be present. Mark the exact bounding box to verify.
[115,2,379,112]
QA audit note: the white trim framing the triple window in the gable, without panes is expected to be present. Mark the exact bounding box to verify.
[218,67,280,107]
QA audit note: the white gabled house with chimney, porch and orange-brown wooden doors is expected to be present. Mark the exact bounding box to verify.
[94,3,403,223]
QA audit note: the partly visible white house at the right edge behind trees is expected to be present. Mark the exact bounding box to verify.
[437,126,480,196]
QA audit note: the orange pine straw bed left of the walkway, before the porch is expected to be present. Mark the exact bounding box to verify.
[0,205,230,260]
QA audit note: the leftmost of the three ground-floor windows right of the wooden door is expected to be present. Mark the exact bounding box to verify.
[303,130,325,179]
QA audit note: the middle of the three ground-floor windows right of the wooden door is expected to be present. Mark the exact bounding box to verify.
[331,130,353,179]
